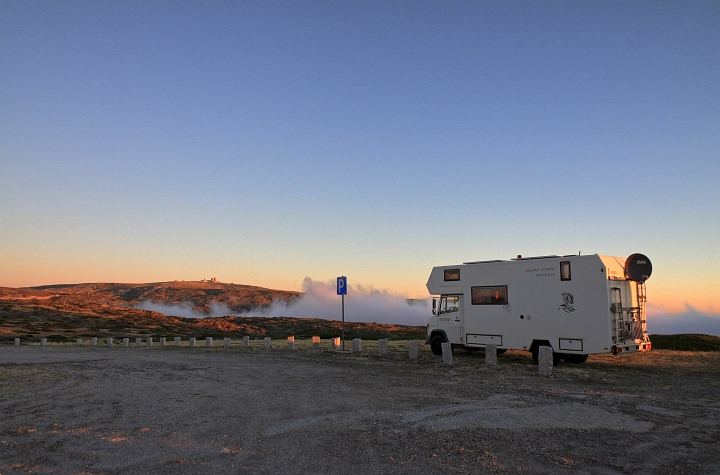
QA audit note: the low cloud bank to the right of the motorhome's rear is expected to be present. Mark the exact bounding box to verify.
[647,304,720,336]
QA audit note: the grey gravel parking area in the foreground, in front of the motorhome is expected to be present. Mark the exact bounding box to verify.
[0,342,720,475]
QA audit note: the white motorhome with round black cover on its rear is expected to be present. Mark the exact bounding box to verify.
[426,254,652,364]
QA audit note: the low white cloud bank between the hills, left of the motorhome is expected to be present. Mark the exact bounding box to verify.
[135,277,432,325]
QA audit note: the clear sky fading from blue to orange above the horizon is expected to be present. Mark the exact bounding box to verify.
[0,0,720,328]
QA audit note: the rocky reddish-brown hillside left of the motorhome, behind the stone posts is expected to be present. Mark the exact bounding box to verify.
[0,281,425,343]
